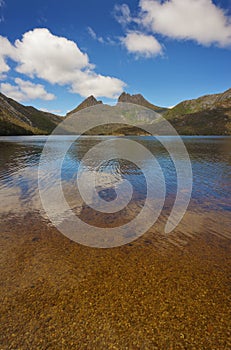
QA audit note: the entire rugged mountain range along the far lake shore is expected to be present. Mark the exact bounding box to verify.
[0,89,231,136]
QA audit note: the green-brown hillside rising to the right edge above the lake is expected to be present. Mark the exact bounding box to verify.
[164,89,231,135]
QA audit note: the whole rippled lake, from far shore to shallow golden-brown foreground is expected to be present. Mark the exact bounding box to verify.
[0,136,231,349]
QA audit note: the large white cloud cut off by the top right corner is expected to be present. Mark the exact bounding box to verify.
[140,0,231,47]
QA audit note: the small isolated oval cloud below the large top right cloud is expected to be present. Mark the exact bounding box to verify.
[121,31,162,57]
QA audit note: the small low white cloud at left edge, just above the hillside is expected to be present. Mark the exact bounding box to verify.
[0,78,55,102]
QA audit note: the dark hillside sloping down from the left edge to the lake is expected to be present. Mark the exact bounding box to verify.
[0,93,63,135]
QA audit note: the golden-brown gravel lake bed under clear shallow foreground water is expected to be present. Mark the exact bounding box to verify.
[0,136,231,350]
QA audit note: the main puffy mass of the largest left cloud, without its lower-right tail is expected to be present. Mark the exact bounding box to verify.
[15,28,90,84]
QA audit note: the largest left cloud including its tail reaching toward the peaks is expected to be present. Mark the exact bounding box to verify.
[0,28,125,98]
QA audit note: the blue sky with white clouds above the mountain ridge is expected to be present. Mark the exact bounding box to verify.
[0,0,231,115]
